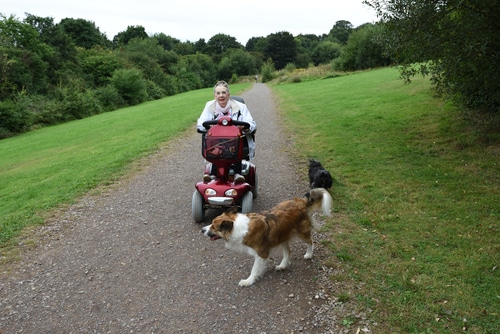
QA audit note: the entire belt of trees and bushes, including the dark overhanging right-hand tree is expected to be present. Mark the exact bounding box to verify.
[0,0,500,138]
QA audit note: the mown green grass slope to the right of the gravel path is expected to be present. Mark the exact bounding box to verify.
[273,69,500,333]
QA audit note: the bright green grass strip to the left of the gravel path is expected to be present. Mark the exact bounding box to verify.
[0,84,249,246]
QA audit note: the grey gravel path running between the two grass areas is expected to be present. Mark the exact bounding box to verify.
[0,84,374,334]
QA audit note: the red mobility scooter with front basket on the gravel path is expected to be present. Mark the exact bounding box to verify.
[192,105,257,223]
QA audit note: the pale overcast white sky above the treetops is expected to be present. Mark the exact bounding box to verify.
[0,0,377,45]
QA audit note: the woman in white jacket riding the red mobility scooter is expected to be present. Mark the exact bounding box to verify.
[197,81,257,182]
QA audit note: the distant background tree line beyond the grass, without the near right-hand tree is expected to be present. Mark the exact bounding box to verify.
[0,13,388,138]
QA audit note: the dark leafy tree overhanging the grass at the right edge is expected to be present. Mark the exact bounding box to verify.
[364,0,500,113]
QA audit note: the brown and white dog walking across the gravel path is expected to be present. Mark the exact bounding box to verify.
[202,188,332,286]
